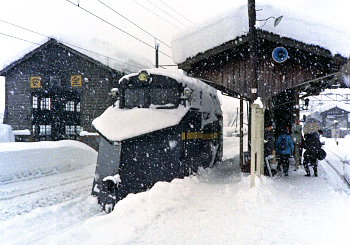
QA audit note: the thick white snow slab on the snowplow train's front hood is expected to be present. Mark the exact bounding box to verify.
[92,106,189,142]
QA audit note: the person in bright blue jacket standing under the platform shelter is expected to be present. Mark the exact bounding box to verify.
[276,127,294,176]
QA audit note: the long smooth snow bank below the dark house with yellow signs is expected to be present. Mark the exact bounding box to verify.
[0,140,97,184]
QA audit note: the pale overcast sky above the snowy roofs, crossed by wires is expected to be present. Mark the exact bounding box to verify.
[0,0,350,117]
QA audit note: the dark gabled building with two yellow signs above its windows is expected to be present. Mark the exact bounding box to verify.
[0,39,124,147]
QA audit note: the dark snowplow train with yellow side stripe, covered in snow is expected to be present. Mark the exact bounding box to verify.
[92,69,223,212]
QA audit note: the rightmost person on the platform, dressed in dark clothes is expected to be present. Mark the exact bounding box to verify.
[303,132,322,177]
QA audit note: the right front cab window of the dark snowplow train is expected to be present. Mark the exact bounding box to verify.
[150,88,179,107]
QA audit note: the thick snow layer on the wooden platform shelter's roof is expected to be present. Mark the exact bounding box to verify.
[171,4,350,64]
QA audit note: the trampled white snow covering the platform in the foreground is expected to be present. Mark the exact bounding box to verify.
[45,162,350,245]
